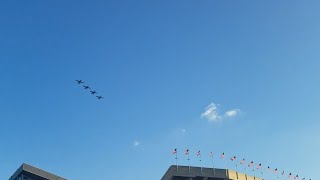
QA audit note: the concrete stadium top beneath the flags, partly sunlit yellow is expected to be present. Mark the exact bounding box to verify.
[161,165,262,180]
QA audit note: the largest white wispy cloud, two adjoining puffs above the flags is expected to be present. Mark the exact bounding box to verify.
[201,102,240,122]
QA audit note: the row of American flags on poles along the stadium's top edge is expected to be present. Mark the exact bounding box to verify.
[172,148,311,180]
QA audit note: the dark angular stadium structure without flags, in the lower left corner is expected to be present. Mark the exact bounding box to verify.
[9,164,66,180]
